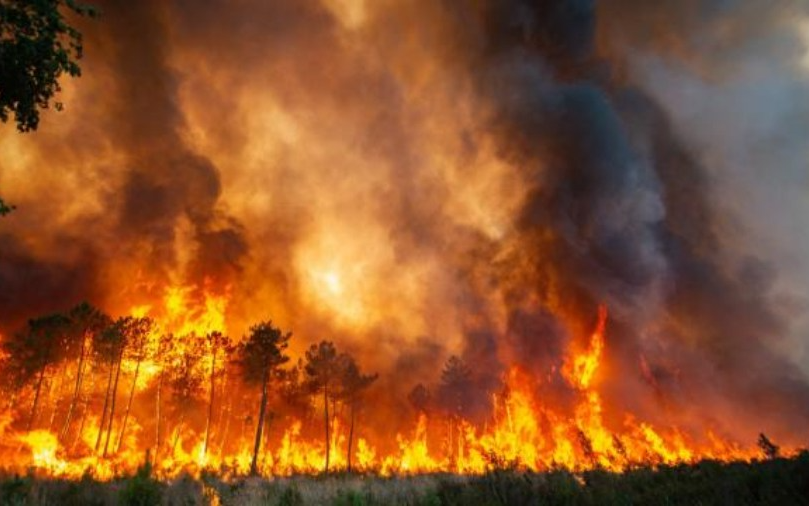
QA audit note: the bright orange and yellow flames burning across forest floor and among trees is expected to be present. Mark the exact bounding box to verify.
[0,288,792,478]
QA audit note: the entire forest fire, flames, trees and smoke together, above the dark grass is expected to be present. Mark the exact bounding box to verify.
[0,0,809,486]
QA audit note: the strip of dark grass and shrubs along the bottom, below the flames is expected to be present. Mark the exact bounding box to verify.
[0,452,809,506]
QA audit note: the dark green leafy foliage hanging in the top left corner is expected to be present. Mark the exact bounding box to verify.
[0,0,96,132]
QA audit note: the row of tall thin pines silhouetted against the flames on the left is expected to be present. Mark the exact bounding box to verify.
[0,303,377,474]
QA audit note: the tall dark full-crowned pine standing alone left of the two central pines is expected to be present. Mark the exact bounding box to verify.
[238,320,292,475]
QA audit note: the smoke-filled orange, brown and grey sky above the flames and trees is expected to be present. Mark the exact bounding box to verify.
[0,0,809,442]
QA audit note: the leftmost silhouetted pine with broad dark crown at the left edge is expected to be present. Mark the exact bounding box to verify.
[2,314,70,430]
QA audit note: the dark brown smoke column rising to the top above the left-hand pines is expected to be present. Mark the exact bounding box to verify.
[100,2,247,287]
